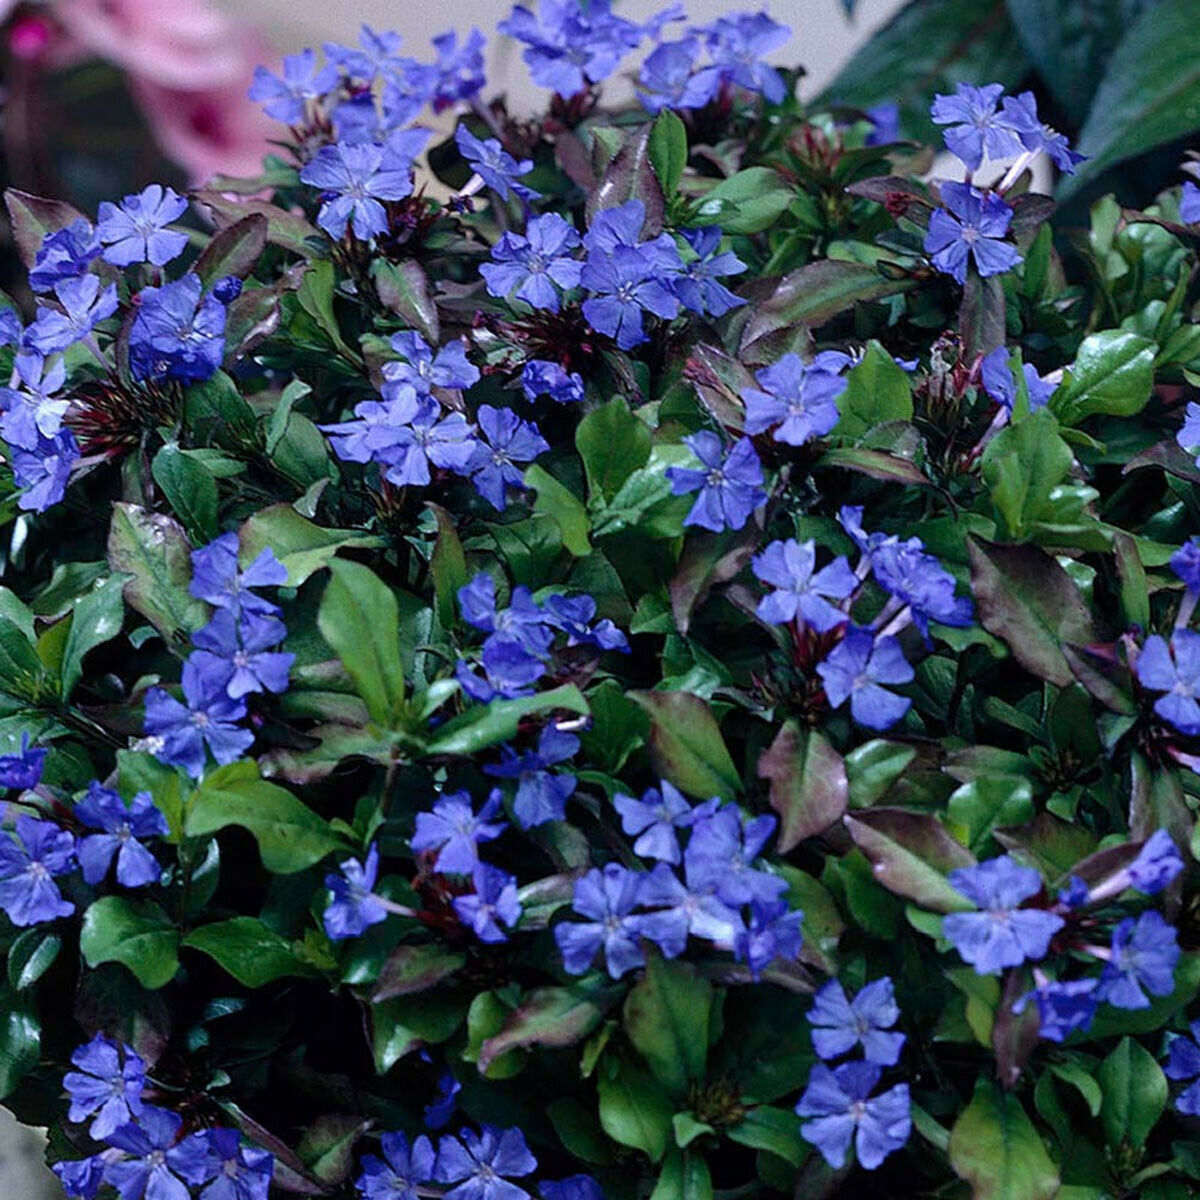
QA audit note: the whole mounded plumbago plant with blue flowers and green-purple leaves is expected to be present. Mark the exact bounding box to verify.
[9,7,1200,1200]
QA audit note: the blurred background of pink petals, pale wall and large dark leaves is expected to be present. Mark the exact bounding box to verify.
[0,0,1200,1200]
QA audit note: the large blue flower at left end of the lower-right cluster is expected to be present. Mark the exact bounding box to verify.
[942,854,1063,974]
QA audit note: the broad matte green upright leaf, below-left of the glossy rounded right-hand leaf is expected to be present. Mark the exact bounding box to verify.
[982,408,1075,541]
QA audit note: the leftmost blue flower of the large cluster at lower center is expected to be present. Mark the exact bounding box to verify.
[554,863,646,979]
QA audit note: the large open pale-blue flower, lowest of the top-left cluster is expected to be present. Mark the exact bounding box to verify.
[300,142,413,241]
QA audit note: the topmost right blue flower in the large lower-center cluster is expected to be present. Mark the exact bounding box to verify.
[683,804,787,907]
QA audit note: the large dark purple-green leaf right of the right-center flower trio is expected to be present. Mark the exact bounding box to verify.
[967,538,1096,688]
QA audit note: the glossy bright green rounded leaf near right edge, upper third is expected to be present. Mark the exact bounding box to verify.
[1050,331,1156,426]
